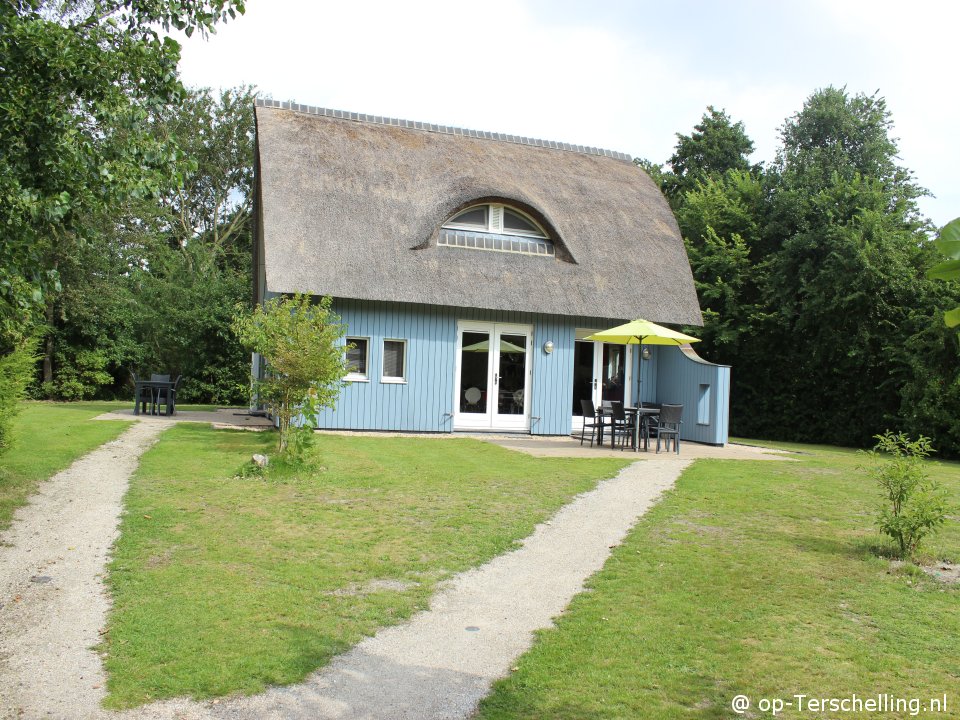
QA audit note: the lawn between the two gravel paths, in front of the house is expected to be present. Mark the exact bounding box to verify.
[102,424,629,708]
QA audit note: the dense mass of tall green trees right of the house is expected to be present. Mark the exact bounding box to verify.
[662,88,960,455]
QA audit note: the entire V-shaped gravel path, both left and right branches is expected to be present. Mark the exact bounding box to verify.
[0,419,692,720]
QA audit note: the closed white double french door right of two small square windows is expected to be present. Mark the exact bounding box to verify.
[453,320,533,431]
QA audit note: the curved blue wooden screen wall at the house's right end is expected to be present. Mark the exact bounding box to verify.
[656,345,730,445]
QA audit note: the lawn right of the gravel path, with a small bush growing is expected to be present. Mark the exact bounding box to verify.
[479,445,960,720]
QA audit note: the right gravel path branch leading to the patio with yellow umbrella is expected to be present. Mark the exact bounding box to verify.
[122,456,692,720]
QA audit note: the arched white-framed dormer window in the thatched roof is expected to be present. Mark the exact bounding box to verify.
[438,203,555,257]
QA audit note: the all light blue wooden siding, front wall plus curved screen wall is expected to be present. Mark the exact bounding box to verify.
[300,299,730,445]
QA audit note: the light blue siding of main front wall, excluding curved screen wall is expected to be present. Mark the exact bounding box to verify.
[317,299,622,435]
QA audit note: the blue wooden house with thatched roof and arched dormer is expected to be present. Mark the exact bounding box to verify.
[254,100,729,444]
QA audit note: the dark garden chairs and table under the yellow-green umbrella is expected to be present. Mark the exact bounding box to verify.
[580,399,683,455]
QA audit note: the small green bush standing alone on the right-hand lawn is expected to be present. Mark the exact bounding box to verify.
[868,430,947,559]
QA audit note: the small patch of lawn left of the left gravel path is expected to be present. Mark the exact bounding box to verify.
[0,402,130,530]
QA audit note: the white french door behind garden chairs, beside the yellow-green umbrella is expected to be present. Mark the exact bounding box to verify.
[571,330,633,432]
